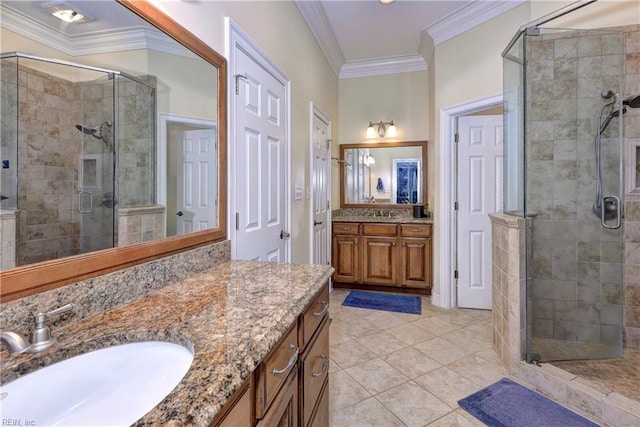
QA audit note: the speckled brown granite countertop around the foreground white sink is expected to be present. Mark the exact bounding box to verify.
[0,261,332,426]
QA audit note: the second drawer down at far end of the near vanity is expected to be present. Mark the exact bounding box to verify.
[300,318,329,426]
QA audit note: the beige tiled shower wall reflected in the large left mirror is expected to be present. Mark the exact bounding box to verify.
[0,60,159,266]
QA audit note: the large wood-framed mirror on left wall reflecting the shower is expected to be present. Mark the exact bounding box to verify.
[0,0,227,301]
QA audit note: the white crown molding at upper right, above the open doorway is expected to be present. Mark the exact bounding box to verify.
[425,0,526,45]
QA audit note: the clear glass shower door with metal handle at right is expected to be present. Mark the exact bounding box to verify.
[523,29,623,361]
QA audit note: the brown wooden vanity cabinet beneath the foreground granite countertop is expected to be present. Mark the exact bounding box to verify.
[211,283,329,427]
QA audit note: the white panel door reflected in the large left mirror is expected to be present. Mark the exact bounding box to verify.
[176,129,217,234]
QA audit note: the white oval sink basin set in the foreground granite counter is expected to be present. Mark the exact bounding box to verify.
[0,341,193,426]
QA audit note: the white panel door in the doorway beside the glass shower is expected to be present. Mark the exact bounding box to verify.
[457,116,503,309]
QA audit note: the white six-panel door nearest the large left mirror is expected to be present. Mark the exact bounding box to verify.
[232,49,288,262]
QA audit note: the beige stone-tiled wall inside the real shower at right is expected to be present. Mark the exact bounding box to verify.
[526,26,640,347]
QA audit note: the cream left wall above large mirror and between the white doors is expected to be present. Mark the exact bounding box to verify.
[154,0,339,262]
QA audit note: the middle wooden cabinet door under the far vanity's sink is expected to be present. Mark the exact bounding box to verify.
[362,237,398,285]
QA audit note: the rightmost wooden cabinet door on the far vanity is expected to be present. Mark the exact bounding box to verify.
[400,238,431,288]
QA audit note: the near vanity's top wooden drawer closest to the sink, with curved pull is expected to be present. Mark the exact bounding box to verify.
[256,323,300,418]
